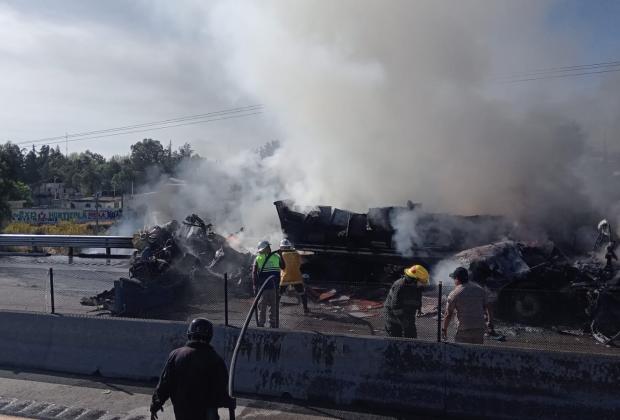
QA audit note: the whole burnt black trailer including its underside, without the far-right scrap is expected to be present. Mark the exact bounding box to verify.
[274,200,510,283]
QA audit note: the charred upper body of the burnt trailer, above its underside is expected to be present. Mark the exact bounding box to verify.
[274,200,510,264]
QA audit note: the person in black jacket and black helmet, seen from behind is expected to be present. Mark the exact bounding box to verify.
[151,318,234,420]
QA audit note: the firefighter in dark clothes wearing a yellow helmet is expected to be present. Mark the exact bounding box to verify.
[383,264,429,338]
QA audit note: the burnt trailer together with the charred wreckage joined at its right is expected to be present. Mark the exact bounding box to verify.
[274,201,620,344]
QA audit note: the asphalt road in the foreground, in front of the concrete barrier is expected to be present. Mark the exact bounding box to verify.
[0,368,443,420]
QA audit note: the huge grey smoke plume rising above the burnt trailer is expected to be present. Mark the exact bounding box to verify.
[206,0,604,249]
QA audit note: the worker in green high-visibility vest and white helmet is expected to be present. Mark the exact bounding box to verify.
[252,241,280,328]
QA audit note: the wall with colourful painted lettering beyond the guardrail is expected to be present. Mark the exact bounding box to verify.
[12,209,123,224]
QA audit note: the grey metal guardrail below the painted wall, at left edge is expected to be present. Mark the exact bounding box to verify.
[0,234,134,249]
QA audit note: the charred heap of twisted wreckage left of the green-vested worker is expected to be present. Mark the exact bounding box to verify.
[81,214,252,315]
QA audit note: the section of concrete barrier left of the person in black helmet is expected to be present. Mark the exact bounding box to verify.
[0,311,186,379]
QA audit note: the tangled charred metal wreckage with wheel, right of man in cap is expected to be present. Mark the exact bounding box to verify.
[453,236,620,344]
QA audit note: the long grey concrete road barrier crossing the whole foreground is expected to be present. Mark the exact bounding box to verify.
[0,312,620,419]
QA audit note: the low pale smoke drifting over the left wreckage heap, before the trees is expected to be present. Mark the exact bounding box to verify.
[118,151,284,249]
